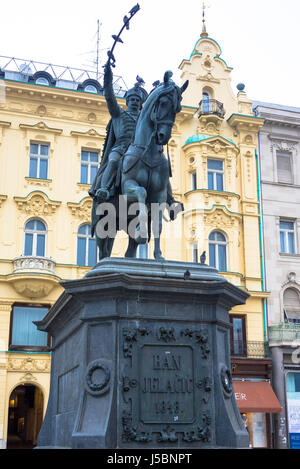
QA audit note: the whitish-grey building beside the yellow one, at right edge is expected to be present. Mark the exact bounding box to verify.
[254,102,300,448]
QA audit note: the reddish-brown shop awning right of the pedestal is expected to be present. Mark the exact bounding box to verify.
[233,381,282,414]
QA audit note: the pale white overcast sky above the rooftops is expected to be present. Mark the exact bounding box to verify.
[0,0,300,107]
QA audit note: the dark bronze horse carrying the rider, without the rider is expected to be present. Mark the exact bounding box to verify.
[92,71,188,260]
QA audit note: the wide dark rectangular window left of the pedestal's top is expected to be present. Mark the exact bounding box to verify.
[10,306,48,350]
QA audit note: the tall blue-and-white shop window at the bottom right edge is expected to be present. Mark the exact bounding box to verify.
[286,373,300,449]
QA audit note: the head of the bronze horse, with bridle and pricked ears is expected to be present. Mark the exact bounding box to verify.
[148,72,188,145]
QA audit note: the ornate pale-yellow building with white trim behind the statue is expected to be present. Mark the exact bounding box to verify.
[0,34,267,448]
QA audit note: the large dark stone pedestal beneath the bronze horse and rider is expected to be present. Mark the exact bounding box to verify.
[37,258,249,449]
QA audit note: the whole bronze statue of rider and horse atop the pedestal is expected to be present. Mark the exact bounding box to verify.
[89,65,188,260]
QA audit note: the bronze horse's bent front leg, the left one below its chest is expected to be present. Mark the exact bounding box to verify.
[123,179,148,244]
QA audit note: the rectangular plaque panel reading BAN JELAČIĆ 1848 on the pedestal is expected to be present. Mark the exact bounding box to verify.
[139,345,195,424]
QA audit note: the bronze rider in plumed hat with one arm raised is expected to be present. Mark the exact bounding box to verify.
[89,62,148,202]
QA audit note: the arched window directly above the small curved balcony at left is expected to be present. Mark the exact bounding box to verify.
[24,219,47,257]
